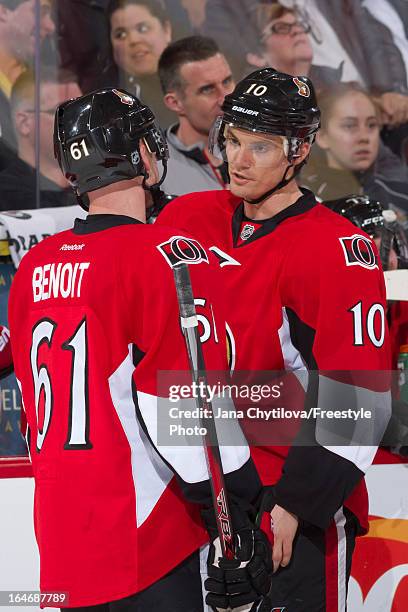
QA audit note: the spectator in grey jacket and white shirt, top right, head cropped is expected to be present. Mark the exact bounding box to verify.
[292,0,408,127]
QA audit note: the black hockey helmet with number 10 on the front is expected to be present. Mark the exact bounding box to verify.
[210,68,320,163]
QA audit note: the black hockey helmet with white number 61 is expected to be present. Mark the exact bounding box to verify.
[54,89,168,209]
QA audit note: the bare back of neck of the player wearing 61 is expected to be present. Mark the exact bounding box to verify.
[88,180,146,223]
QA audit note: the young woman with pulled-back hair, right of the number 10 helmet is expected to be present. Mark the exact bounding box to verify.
[299,83,408,229]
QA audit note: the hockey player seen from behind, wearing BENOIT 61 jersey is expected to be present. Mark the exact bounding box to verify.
[9,89,272,612]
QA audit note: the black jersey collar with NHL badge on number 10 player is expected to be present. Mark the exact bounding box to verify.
[232,188,317,248]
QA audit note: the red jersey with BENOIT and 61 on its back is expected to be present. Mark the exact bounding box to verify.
[9,215,260,607]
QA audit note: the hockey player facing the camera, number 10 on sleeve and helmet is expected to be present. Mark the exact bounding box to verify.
[158,68,390,612]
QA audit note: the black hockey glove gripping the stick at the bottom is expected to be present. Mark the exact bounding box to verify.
[202,504,273,612]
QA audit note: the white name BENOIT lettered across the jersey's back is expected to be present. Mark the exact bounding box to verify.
[32,261,90,302]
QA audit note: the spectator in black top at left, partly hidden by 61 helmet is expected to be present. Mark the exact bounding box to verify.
[0,71,81,210]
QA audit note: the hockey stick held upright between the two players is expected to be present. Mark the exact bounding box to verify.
[173,262,234,559]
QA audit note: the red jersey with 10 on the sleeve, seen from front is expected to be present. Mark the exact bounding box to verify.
[158,190,391,530]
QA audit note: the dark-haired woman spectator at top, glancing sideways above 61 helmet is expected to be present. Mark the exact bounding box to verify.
[108,0,174,127]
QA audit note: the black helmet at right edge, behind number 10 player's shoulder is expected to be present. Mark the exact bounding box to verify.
[324,195,408,270]
